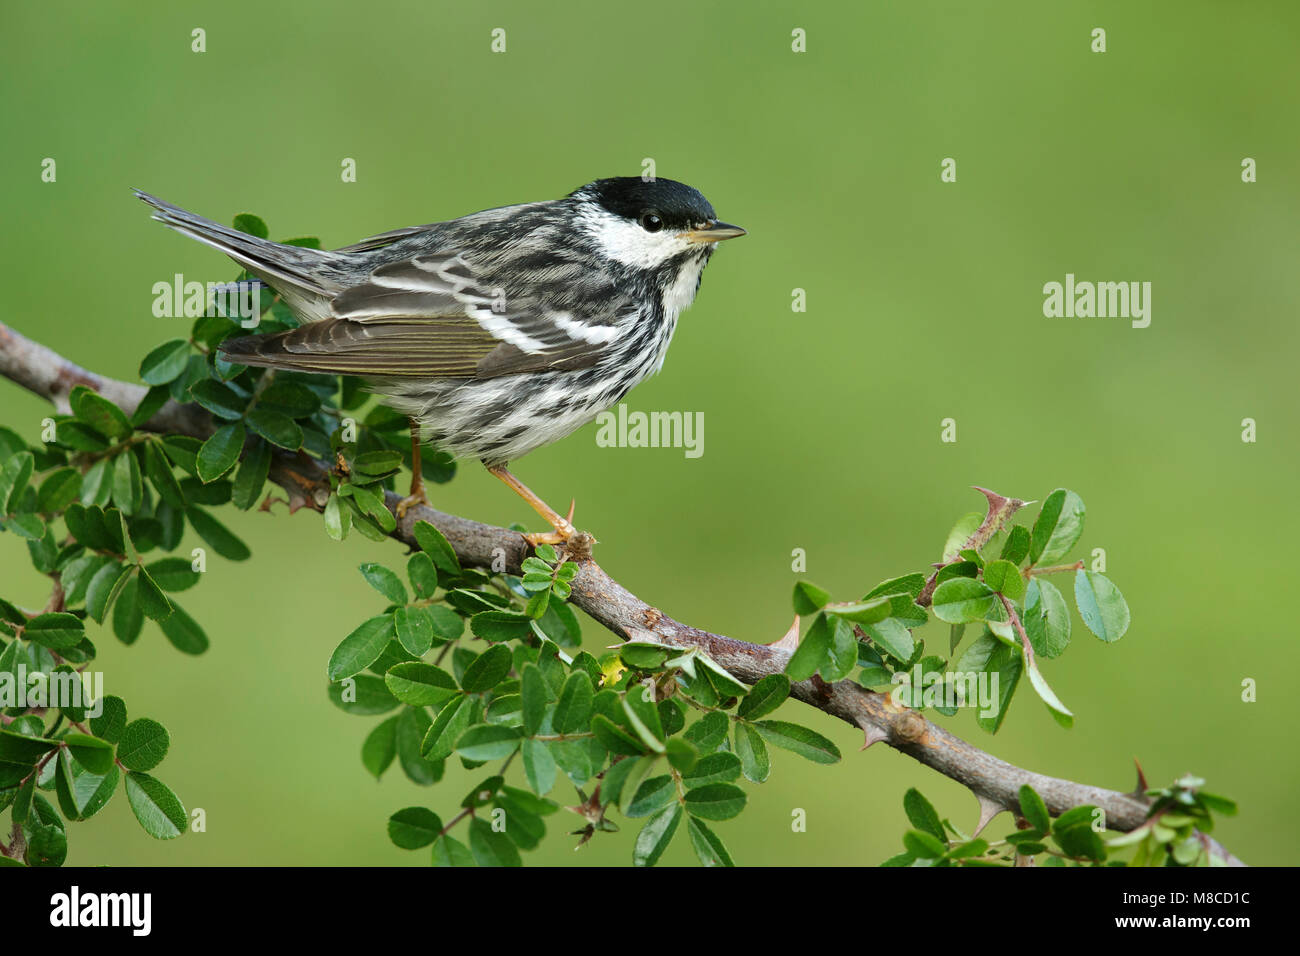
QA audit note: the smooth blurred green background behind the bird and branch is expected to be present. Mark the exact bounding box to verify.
[0,0,1300,865]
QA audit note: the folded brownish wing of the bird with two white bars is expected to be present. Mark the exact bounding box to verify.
[222,254,633,378]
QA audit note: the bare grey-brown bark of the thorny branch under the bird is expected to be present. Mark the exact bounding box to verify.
[0,323,1244,866]
